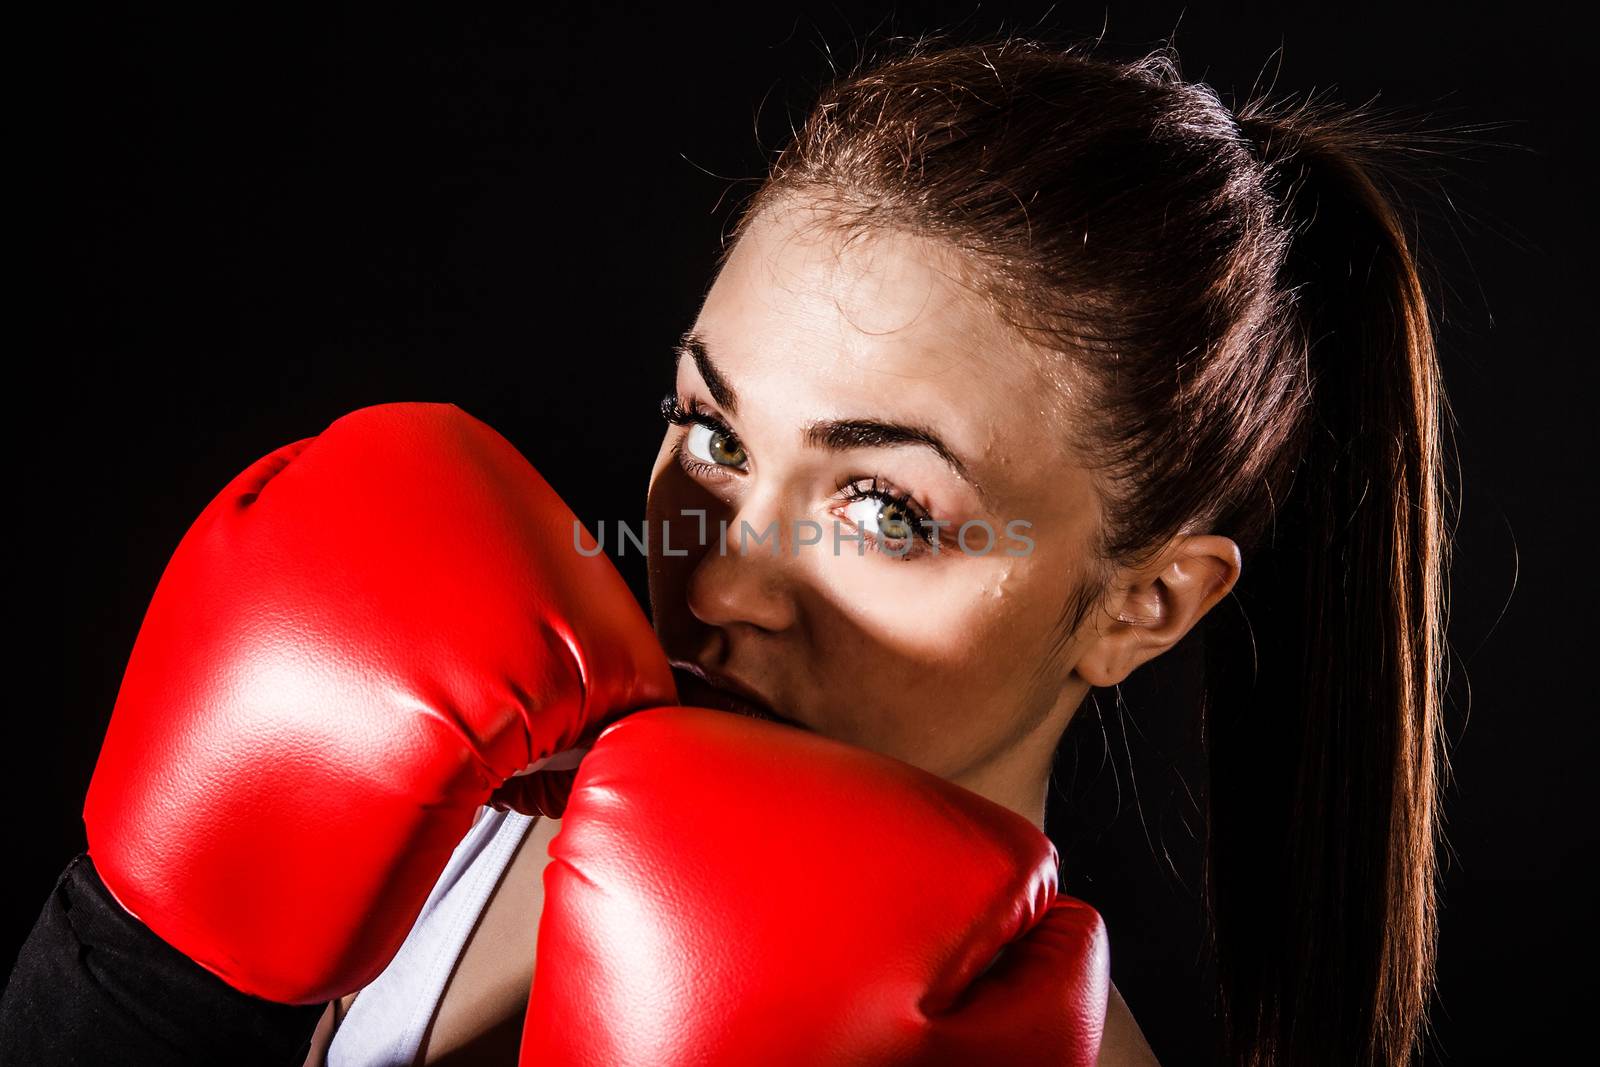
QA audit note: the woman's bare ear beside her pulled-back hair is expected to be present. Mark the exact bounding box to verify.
[1074,534,1243,686]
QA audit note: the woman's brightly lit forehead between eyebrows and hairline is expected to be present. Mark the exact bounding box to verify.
[696,200,1066,474]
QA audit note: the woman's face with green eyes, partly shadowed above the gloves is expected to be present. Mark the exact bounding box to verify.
[648,202,1098,821]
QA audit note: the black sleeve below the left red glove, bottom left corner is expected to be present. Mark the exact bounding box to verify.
[0,853,326,1067]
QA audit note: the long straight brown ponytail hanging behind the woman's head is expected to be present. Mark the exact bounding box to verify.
[1203,106,1448,1065]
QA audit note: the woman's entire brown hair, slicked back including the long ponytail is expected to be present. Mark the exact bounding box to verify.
[728,37,1453,1064]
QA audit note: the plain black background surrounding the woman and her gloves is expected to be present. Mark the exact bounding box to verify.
[12,3,1595,1064]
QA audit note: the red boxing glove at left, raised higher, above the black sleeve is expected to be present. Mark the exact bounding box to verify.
[83,403,675,1003]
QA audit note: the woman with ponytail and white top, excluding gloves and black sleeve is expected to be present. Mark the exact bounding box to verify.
[307,38,1448,1064]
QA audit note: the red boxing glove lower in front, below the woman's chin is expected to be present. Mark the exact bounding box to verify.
[522,709,1110,1067]
